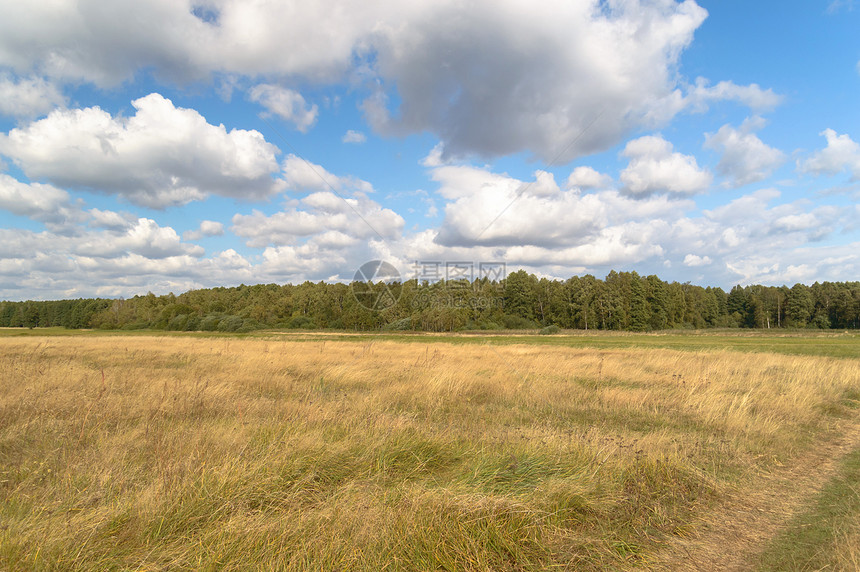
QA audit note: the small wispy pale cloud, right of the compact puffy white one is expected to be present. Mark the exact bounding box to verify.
[705,117,785,187]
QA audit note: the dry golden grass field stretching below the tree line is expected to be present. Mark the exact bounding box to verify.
[0,330,860,571]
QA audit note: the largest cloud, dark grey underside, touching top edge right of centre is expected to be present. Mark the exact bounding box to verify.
[365,1,707,161]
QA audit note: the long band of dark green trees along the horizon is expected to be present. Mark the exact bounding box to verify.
[0,270,860,332]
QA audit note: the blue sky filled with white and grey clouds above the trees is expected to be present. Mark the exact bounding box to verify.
[0,0,860,300]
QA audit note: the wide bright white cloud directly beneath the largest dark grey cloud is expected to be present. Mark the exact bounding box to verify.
[425,165,689,265]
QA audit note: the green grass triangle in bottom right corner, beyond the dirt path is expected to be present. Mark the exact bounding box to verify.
[757,449,860,571]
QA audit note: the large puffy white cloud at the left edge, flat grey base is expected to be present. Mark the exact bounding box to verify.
[0,93,284,208]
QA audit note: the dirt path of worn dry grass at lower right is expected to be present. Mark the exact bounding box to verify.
[644,417,860,572]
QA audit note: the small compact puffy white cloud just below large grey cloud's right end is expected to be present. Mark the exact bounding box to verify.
[619,135,713,197]
